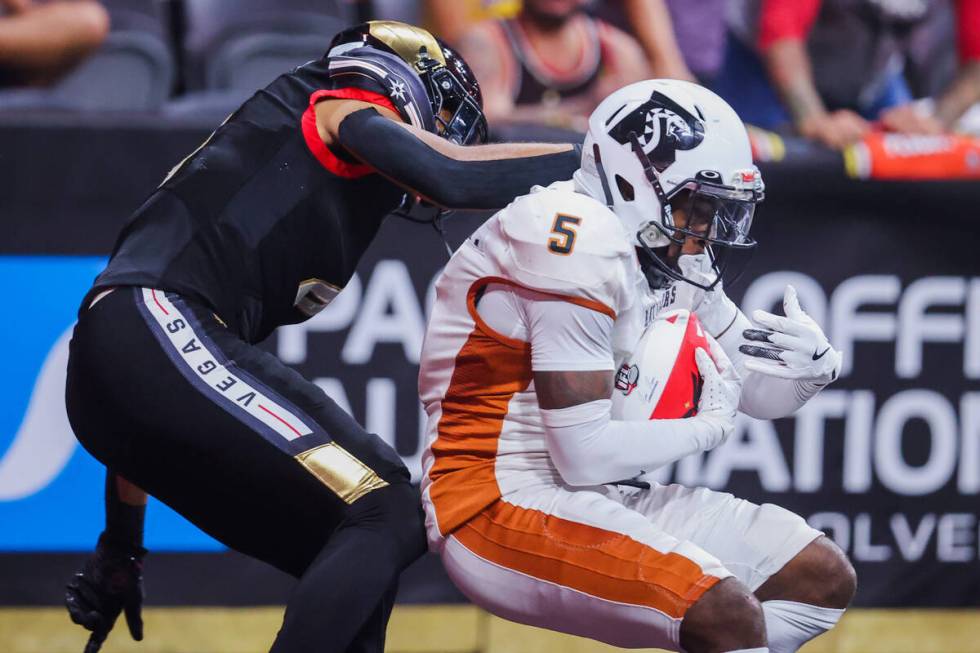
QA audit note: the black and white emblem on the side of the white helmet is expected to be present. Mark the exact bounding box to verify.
[609,91,704,172]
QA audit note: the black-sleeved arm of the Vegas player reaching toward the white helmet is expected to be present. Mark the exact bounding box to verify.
[317,100,580,209]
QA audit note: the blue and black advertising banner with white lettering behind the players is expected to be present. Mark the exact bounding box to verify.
[0,139,980,606]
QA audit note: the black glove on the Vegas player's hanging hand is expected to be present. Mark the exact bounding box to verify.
[65,533,146,653]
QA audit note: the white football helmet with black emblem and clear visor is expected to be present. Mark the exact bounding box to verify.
[574,79,765,290]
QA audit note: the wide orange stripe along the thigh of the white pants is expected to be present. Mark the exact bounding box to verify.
[453,501,719,619]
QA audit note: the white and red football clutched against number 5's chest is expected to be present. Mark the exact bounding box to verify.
[612,309,709,420]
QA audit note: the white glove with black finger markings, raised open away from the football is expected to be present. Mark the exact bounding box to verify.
[738,286,841,385]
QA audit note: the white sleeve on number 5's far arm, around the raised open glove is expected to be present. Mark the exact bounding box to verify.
[717,310,823,419]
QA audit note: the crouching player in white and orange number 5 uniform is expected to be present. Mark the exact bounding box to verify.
[419,80,855,653]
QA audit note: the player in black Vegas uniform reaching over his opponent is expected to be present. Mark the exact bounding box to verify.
[67,22,578,653]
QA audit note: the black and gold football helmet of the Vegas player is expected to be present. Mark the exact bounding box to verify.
[328,20,488,145]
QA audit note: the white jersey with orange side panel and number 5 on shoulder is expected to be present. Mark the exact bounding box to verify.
[419,182,650,547]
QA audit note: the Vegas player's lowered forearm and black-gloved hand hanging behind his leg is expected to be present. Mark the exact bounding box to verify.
[65,471,146,653]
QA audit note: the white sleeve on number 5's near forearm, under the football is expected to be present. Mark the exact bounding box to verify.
[541,399,722,485]
